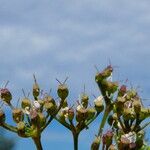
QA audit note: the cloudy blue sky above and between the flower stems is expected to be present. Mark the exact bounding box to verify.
[0,0,150,150]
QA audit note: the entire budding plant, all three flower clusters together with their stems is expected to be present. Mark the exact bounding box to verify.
[0,65,150,150]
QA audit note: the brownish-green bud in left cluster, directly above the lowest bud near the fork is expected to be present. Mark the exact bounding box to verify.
[12,108,24,123]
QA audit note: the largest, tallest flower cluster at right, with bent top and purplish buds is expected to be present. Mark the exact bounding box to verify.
[93,65,150,150]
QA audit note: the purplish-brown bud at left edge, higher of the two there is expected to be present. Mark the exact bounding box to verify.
[0,88,12,104]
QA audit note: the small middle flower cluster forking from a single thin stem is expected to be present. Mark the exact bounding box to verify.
[55,93,104,142]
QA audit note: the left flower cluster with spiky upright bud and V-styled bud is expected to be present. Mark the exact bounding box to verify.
[0,76,69,149]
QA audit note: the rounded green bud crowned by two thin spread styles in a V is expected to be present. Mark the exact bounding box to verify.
[57,84,69,100]
